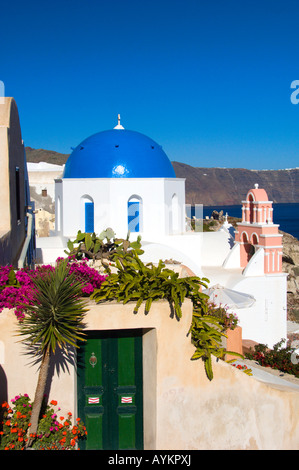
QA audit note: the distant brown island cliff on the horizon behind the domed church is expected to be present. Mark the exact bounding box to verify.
[26,147,299,206]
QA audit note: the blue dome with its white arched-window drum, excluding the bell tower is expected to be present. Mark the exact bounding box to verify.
[55,119,185,238]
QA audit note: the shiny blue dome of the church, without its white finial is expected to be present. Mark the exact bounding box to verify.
[63,128,175,178]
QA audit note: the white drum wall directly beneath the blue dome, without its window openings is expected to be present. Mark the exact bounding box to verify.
[55,178,185,238]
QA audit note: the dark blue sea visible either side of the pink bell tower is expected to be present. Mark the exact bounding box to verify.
[198,203,299,240]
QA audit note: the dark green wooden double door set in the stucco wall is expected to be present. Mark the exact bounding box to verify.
[77,330,143,450]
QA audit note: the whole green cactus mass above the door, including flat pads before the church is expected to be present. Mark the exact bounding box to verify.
[66,229,242,380]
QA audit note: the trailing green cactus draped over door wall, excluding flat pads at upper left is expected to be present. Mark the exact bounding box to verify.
[91,237,241,380]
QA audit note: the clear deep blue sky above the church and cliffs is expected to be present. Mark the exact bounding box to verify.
[0,0,299,169]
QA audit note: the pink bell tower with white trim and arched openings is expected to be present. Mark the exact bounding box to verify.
[235,184,282,274]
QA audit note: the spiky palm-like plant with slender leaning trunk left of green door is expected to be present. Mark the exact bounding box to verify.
[19,261,87,447]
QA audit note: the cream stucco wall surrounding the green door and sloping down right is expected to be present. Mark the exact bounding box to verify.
[0,301,299,450]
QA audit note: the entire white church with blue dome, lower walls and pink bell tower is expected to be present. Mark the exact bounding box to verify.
[37,115,287,347]
